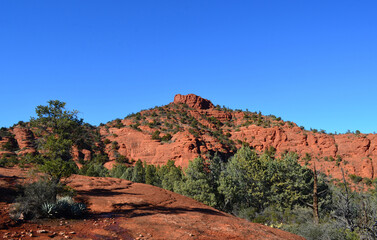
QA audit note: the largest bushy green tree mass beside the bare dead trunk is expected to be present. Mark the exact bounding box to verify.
[218,146,331,219]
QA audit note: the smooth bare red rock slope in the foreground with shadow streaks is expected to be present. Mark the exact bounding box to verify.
[0,168,304,240]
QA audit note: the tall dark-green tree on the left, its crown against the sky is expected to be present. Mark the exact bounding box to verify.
[30,100,85,182]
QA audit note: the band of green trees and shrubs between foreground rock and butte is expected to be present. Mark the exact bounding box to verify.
[95,146,377,239]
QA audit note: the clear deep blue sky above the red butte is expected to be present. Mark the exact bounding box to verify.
[0,0,377,133]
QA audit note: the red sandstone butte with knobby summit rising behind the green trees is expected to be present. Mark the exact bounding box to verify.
[0,94,377,179]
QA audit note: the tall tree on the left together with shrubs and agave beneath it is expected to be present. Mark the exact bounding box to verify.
[6,100,93,220]
